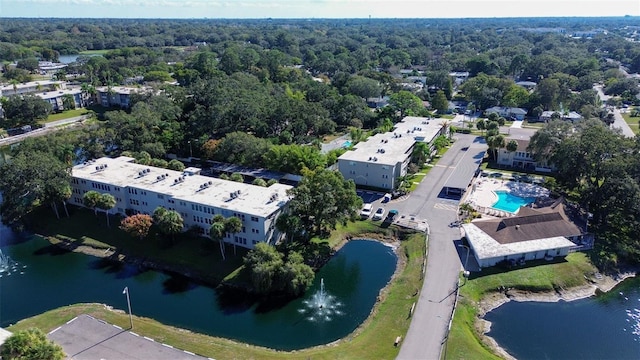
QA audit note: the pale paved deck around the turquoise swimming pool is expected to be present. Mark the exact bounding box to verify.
[464,177,549,217]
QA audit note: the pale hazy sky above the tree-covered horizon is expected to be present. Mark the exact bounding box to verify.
[0,0,640,19]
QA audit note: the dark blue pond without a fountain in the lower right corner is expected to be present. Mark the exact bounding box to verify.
[485,278,640,360]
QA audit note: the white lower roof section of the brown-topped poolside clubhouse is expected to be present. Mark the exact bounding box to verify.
[462,223,575,259]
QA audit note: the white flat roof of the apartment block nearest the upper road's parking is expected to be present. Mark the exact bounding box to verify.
[338,116,442,165]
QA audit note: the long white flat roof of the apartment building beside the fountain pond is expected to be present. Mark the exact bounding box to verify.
[73,156,292,217]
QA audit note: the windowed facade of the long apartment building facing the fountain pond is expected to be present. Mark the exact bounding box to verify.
[70,177,286,249]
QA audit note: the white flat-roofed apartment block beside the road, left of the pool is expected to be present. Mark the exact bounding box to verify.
[338,116,446,190]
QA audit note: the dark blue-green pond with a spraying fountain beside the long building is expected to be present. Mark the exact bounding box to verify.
[0,221,397,350]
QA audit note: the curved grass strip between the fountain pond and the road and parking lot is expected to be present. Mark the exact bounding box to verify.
[8,229,425,359]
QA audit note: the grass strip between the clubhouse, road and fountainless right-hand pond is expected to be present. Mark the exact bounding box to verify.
[445,253,597,359]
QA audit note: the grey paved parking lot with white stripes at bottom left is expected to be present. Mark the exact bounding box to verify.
[47,315,207,360]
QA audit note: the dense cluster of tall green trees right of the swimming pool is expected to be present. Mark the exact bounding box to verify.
[529,120,640,268]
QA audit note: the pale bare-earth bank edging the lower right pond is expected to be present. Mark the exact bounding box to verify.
[474,269,638,360]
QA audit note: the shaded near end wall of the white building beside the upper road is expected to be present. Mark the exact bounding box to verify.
[338,159,398,189]
